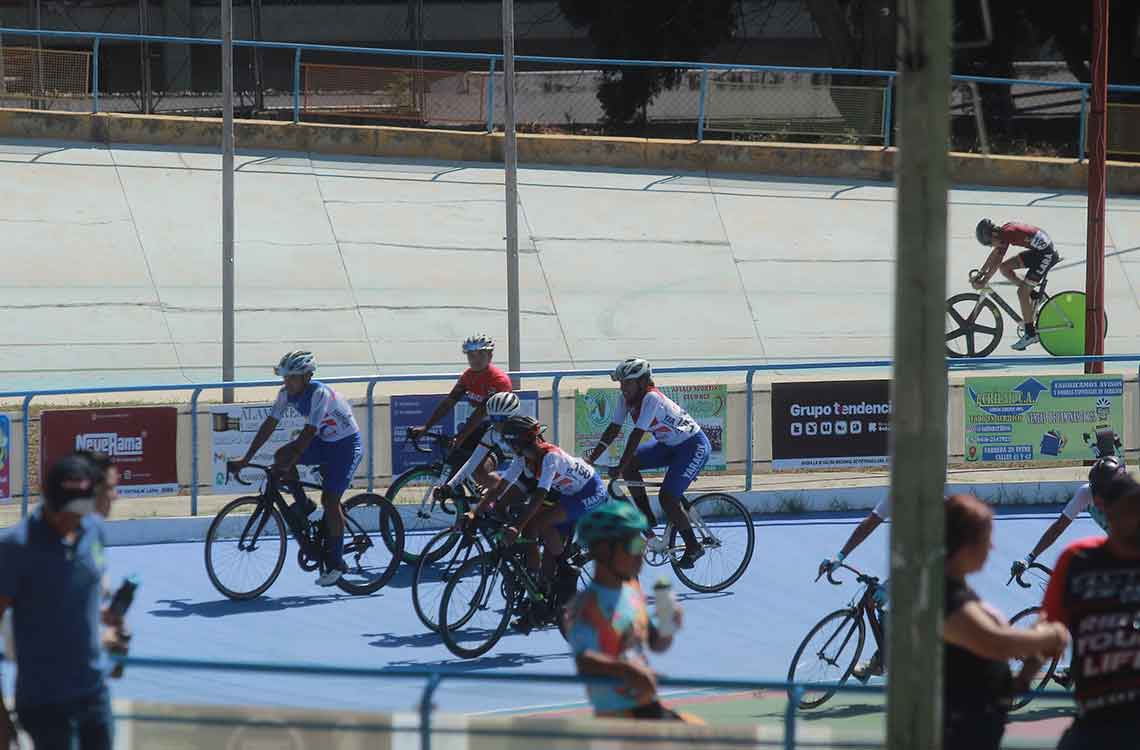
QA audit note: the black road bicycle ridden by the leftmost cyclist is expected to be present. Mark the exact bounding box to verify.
[205,464,404,601]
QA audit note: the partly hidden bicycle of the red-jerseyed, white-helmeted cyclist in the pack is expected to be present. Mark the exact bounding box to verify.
[384,430,479,565]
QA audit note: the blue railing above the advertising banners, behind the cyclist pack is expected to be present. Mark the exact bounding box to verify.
[0,354,1140,515]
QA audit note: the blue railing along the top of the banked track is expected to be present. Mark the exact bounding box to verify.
[0,27,1140,160]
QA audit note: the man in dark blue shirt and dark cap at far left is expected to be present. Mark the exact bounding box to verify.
[0,456,122,750]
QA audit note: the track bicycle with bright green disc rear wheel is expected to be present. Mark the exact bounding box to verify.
[946,269,1108,358]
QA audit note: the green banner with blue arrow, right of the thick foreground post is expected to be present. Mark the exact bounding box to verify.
[964,375,1124,463]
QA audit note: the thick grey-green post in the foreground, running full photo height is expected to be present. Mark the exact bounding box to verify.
[886,0,952,750]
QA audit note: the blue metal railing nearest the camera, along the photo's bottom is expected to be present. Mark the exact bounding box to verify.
[104,657,1073,750]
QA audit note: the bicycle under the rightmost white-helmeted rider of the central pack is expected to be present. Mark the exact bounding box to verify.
[608,479,756,594]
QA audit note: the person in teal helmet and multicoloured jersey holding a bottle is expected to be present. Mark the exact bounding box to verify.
[567,503,684,720]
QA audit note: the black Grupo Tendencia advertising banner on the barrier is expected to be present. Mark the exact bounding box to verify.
[772,381,890,470]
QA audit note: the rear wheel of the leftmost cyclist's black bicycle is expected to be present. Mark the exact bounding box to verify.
[336,492,404,595]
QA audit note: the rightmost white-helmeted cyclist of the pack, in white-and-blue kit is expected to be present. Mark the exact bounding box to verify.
[586,357,713,569]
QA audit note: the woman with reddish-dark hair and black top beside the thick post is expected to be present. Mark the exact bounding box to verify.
[943,495,1069,750]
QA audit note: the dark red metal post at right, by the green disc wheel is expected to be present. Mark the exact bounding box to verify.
[1084,0,1108,373]
